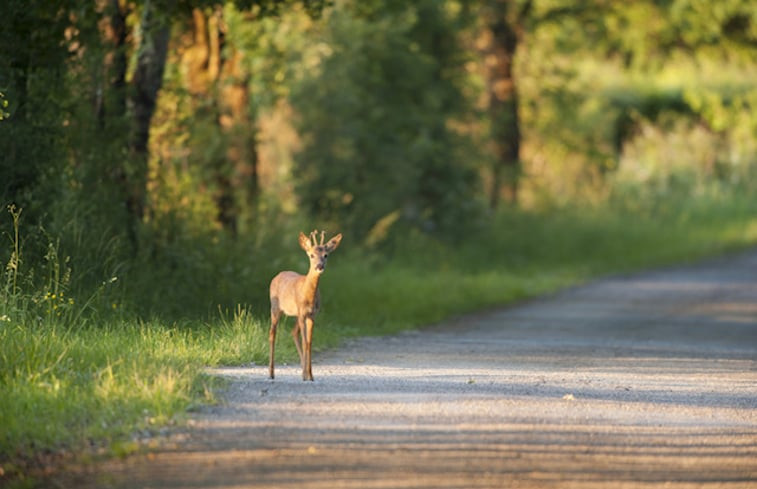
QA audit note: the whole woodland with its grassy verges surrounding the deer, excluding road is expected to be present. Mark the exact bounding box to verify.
[0,0,757,472]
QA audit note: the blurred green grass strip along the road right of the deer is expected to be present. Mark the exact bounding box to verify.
[322,191,757,334]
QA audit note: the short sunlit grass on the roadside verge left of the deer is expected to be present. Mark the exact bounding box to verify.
[0,307,296,472]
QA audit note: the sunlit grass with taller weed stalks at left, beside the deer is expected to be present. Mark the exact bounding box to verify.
[0,208,267,463]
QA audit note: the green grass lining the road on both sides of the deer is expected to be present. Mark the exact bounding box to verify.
[0,192,757,475]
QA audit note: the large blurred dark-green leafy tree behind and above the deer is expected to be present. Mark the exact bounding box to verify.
[293,1,475,241]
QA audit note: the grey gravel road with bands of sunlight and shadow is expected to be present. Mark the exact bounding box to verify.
[74,252,757,488]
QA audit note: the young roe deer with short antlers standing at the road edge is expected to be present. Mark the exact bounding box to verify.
[268,231,342,380]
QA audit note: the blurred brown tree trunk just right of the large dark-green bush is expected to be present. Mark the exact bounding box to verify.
[479,0,530,208]
